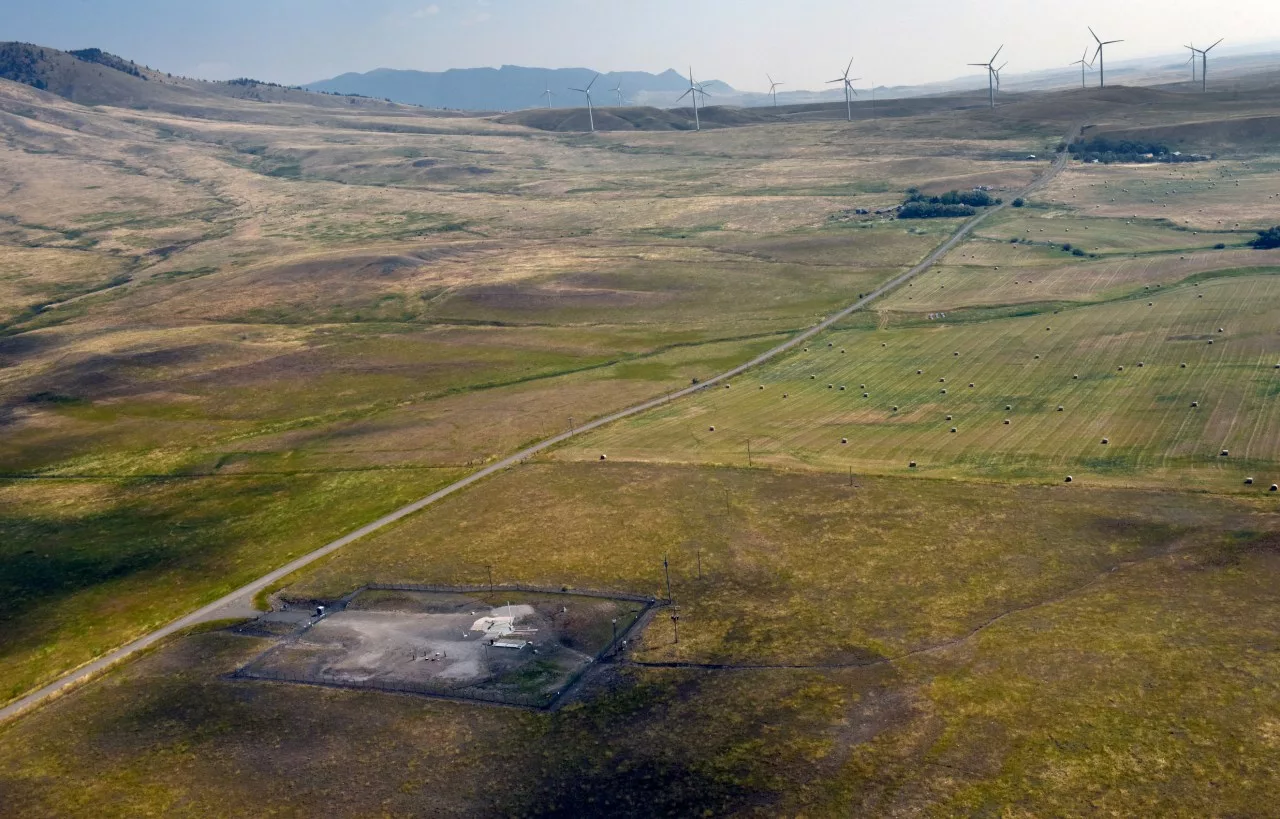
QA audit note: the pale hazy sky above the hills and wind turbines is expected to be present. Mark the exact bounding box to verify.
[10,0,1280,90]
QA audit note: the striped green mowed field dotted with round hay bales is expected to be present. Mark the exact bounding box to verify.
[557,270,1280,491]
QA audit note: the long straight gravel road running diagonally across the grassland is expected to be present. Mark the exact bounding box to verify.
[0,125,1083,722]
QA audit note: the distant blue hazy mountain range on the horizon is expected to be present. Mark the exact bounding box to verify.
[305,65,736,111]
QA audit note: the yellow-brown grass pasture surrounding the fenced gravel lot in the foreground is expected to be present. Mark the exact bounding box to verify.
[0,463,1280,816]
